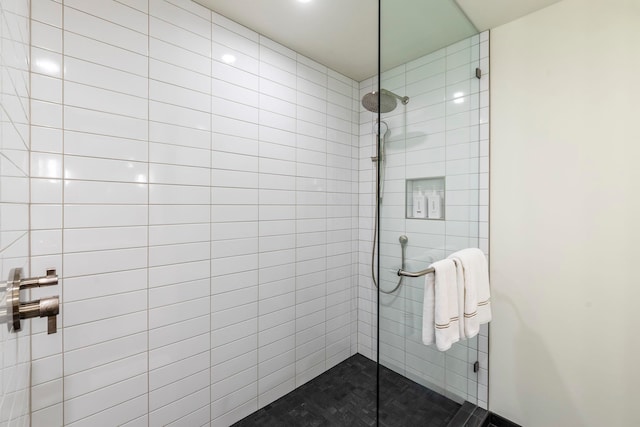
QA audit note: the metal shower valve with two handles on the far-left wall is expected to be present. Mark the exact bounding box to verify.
[0,268,60,334]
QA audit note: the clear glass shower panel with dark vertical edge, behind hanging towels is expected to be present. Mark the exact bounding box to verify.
[372,0,481,426]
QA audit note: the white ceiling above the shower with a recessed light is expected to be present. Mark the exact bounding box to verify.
[195,0,560,81]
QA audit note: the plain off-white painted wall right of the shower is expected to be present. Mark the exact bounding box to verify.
[489,0,640,427]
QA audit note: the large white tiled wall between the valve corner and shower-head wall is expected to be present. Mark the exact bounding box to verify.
[27,0,359,426]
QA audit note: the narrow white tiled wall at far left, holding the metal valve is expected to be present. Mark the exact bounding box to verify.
[0,0,30,426]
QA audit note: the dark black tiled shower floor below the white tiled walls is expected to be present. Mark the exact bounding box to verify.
[234,354,460,427]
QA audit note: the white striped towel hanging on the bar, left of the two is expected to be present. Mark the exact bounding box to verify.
[422,259,460,351]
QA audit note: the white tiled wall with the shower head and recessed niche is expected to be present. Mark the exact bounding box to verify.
[358,32,489,408]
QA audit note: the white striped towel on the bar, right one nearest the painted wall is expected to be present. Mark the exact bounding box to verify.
[448,248,491,338]
